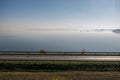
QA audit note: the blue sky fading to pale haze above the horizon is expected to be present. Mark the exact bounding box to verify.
[0,0,120,34]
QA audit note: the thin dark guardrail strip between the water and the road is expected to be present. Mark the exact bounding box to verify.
[0,51,120,56]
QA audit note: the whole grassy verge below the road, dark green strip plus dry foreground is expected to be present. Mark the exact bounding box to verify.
[0,61,120,80]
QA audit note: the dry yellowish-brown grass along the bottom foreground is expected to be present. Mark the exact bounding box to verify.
[0,71,120,80]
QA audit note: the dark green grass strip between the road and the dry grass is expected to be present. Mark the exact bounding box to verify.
[0,61,120,72]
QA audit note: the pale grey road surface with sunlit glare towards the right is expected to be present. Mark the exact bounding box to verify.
[0,55,120,61]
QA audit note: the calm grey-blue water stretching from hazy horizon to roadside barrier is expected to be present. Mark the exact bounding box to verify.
[0,30,120,52]
